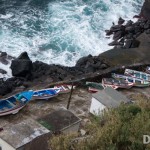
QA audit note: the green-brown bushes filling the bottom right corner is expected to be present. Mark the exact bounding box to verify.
[49,100,150,150]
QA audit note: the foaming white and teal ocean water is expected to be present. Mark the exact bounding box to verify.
[0,0,144,66]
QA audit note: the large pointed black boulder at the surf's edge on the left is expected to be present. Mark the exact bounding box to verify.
[11,52,32,77]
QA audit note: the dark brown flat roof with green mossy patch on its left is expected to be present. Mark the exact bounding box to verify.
[38,109,80,132]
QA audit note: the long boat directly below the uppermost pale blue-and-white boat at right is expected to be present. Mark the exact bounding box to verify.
[112,73,150,87]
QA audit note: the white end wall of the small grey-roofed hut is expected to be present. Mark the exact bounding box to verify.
[90,97,106,115]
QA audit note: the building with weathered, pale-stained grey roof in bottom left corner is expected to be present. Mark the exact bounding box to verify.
[0,119,51,150]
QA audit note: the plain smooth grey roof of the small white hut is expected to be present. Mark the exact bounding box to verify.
[93,87,130,108]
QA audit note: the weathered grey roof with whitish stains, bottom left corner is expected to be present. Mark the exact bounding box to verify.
[0,119,50,149]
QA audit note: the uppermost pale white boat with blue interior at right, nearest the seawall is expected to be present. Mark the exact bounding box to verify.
[124,69,150,82]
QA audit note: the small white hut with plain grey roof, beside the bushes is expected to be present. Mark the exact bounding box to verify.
[90,87,130,115]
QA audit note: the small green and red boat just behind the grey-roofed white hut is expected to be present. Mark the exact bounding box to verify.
[86,82,104,93]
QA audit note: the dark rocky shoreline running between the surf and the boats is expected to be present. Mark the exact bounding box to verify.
[0,0,150,96]
